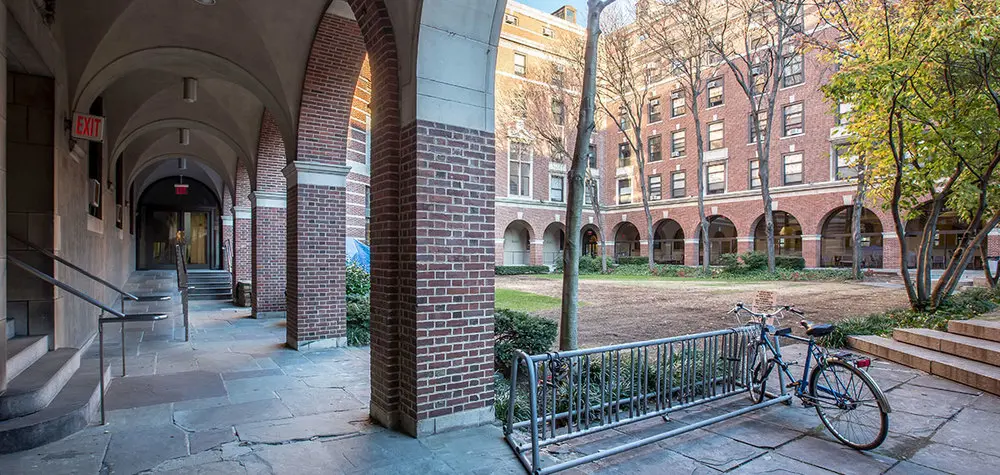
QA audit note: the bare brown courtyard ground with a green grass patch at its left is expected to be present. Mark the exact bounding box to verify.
[496,276,906,347]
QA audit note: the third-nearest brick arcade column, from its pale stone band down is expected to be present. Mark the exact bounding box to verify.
[250,191,285,318]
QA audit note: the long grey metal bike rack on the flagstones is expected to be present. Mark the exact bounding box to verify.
[504,327,791,474]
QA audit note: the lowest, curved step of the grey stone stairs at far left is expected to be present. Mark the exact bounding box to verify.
[0,360,111,454]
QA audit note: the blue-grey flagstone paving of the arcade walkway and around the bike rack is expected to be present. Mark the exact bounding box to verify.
[0,272,1000,475]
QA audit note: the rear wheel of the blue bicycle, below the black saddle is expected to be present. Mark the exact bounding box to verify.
[809,360,889,450]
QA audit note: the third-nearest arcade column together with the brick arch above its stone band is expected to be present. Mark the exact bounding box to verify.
[251,112,286,318]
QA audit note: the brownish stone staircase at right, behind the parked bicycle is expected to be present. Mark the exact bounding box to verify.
[848,320,1000,395]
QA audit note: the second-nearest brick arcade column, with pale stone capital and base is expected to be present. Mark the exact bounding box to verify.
[283,161,350,350]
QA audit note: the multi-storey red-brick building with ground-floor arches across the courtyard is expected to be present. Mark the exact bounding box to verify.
[496,4,1000,268]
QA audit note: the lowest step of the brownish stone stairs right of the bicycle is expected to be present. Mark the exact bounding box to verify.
[847,336,1000,395]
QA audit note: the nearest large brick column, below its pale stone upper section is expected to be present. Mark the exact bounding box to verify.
[371,120,496,436]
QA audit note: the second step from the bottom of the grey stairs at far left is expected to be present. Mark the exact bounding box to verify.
[0,348,80,421]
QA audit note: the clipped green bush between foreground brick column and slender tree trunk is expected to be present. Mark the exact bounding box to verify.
[493,308,558,377]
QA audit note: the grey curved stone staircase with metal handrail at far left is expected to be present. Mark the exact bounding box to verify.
[0,336,110,453]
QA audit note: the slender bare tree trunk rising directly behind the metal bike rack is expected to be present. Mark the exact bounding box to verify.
[559,0,613,351]
